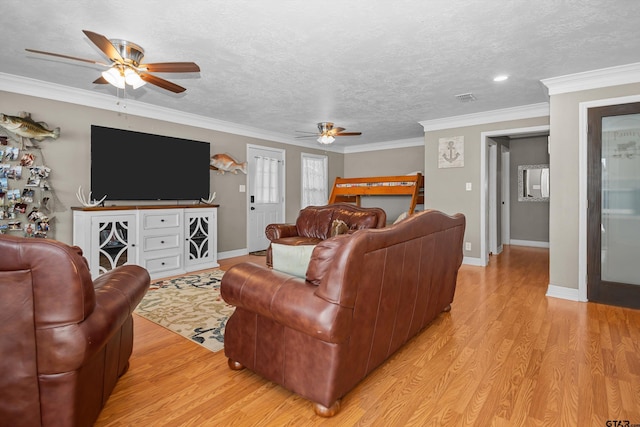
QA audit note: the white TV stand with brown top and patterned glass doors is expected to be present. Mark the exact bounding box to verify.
[72,205,219,279]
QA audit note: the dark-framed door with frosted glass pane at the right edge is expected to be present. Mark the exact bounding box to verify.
[587,103,640,308]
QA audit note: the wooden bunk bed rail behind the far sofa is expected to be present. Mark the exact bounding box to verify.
[329,173,424,215]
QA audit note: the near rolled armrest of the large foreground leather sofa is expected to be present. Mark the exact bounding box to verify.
[220,263,351,343]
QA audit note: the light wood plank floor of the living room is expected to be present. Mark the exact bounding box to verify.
[96,246,640,426]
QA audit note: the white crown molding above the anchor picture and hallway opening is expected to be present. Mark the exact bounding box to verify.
[419,102,549,132]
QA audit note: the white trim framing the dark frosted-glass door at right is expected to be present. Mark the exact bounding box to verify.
[578,95,640,301]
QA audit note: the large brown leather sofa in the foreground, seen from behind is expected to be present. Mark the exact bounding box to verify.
[221,210,465,416]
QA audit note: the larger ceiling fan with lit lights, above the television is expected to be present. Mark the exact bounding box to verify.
[25,30,200,93]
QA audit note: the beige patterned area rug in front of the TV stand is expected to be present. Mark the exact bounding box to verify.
[134,269,234,352]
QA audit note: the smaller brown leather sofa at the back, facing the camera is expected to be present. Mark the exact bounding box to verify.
[265,203,387,267]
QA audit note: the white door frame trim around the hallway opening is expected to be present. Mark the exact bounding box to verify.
[480,125,549,265]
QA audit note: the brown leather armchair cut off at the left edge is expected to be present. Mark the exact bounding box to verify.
[0,235,149,427]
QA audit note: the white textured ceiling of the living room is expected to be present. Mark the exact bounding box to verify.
[0,0,640,147]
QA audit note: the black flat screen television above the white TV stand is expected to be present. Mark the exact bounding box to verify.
[91,125,211,201]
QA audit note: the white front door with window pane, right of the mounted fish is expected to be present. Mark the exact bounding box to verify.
[247,145,285,252]
